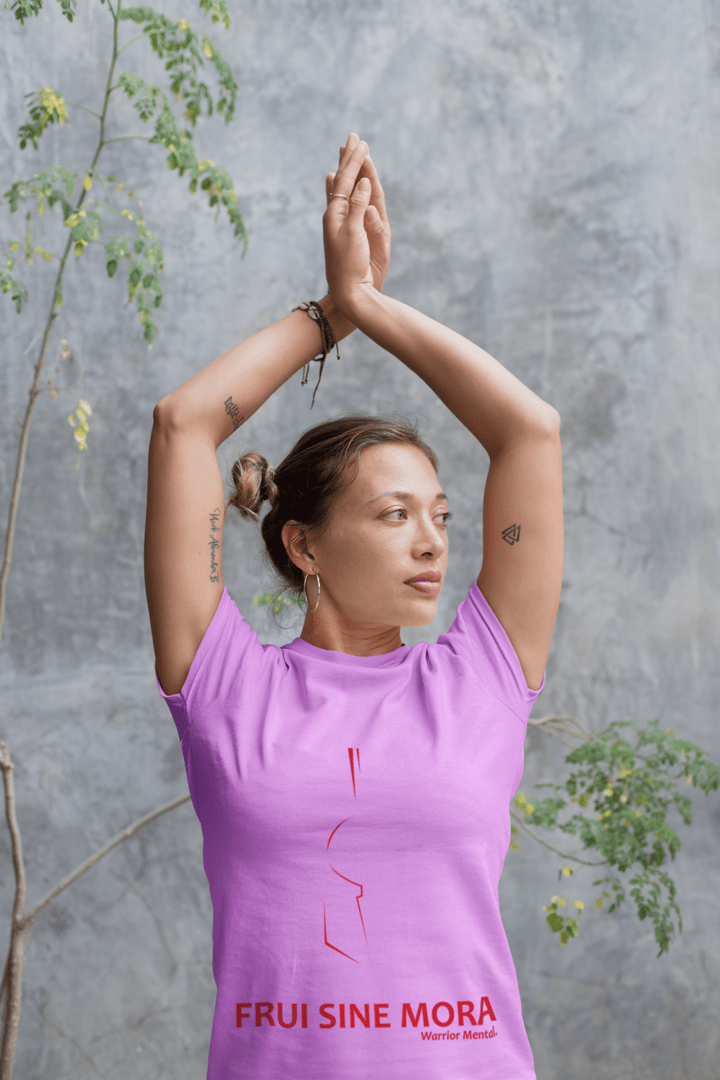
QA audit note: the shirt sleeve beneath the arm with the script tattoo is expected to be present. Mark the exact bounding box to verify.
[155,588,267,741]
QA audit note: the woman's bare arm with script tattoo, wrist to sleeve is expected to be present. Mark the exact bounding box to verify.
[145,296,355,694]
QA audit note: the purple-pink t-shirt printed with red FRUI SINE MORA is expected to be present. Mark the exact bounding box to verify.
[158,581,545,1080]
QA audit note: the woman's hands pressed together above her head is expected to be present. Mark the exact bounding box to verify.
[323,132,392,318]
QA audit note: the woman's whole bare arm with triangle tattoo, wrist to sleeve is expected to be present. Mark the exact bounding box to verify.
[336,291,565,690]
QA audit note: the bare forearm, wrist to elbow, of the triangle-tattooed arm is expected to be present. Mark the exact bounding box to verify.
[342,288,560,458]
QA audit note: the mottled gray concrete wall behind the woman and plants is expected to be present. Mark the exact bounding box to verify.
[0,0,720,1080]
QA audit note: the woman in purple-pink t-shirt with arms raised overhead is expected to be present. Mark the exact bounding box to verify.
[146,133,562,1080]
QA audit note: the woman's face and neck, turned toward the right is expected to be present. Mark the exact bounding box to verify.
[283,443,448,656]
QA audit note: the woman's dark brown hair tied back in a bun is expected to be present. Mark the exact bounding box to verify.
[226,413,438,596]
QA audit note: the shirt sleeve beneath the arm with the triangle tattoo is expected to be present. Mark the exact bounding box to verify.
[437,581,547,723]
